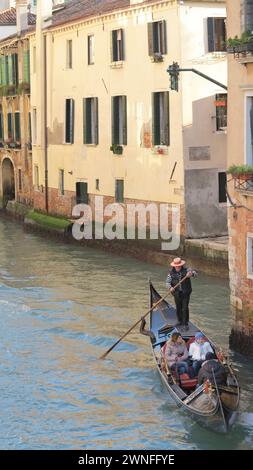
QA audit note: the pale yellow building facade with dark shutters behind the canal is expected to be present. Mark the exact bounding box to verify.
[28,0,226,235]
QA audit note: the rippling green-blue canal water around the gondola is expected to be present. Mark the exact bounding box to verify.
[0,220,253,450]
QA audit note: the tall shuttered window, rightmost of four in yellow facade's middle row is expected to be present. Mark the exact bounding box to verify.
[153,91,170,145]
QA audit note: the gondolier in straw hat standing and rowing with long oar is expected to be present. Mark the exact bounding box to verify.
[166,258,197,330]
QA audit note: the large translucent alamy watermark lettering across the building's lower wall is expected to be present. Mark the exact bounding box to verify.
[72,196,180,251]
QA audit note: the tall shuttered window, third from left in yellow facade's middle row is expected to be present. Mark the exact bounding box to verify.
[112,96,127,145]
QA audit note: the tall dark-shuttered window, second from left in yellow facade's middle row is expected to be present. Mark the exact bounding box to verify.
[83,98,98,145]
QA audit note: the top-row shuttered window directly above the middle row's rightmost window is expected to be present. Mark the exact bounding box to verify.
[148,20,167,56]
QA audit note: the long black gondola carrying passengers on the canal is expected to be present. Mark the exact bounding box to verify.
[145,282,240,433]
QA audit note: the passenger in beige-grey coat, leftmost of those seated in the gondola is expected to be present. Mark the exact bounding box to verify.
[164,332,189,374]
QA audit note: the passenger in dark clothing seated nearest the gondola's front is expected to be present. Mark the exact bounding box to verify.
[198,352,227,385]
